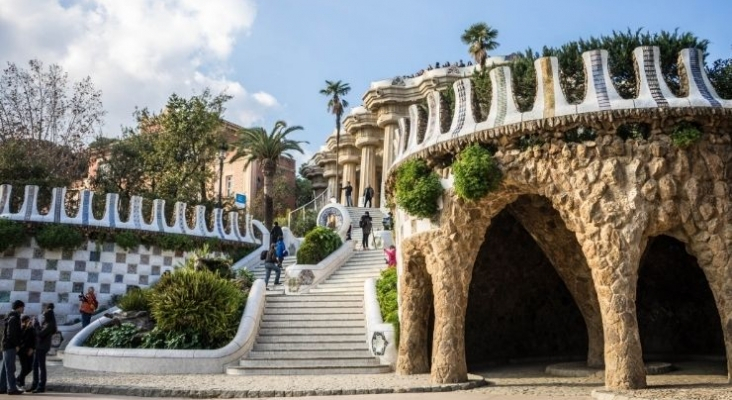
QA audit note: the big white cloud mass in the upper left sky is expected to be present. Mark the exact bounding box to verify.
[0,0,278,136]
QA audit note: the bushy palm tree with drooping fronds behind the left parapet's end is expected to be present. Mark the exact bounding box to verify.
[231,121,308,229]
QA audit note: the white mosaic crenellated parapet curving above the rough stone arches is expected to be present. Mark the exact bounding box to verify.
[391,46,732,172]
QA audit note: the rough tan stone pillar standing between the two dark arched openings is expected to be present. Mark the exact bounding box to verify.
[577,220,647,389]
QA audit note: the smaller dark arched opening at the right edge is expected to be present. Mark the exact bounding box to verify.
[636,236,725,361]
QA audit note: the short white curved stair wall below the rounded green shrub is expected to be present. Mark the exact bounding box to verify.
[285,241,353,294]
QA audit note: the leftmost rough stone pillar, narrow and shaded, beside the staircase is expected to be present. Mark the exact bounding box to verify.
[396,238,432,375]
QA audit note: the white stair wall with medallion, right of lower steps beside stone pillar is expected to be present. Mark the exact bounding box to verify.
[363,278,397,366]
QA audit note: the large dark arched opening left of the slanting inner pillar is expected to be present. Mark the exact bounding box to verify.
[465,209,588,368]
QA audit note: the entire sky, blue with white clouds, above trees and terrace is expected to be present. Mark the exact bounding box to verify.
[0,0,732,167]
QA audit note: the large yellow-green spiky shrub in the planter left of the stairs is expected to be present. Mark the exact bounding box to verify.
[150,268,246,348]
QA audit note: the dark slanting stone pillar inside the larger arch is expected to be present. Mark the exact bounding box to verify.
[508,196,604,367]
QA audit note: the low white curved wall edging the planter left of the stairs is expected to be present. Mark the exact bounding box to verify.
[63,279,265,374]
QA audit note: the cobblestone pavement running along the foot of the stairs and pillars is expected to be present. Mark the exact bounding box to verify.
[43,362,732,400]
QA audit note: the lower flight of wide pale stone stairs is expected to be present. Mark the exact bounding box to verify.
[226,250,391,375]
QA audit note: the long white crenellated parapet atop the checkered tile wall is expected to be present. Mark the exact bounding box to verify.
[0,185,266,244]
